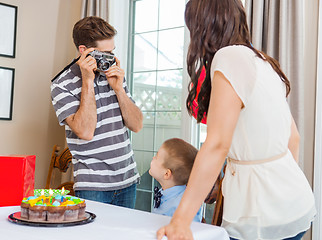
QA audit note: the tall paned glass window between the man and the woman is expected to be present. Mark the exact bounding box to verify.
[128,0,185,211]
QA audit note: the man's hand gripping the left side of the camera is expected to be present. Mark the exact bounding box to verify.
[77,48,97,82]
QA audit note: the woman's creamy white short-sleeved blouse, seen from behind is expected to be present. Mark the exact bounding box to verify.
[211,45,316,240]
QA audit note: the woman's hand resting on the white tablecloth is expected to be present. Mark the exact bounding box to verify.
[157,219,193,240]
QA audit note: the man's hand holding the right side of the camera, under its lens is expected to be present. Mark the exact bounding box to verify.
[105,57,125,93]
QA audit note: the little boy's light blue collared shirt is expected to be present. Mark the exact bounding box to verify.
[152,185,202,222]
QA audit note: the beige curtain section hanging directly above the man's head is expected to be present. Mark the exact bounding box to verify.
[81,0,108,19]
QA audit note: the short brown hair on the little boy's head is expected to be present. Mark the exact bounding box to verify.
[162,138,198,185]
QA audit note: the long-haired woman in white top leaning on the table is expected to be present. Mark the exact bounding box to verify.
[157,0,316,240]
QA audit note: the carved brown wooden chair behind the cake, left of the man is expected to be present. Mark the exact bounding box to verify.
[46,145,75,196]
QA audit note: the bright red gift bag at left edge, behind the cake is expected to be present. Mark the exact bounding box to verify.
[0,155,36,207]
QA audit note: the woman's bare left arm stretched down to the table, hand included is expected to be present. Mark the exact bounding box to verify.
[157,72,243,240]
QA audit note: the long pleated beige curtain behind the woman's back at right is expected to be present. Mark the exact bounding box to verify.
[245,0,305,168]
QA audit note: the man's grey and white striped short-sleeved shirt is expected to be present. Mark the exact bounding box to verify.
[51,64,139,191]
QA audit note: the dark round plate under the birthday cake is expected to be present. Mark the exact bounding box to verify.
[8,212,96,227]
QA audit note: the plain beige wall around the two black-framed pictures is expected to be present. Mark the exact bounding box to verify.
[0,0,82,188]
